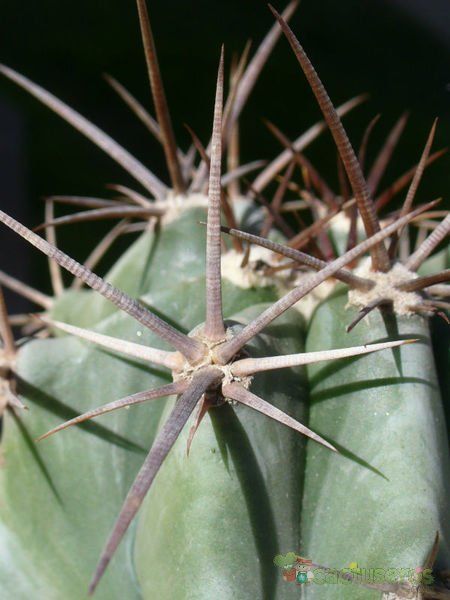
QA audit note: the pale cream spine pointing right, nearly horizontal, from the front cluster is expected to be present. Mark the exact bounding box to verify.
[231,340,410,377]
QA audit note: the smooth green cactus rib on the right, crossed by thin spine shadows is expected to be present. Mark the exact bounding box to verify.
[302,290,450,600]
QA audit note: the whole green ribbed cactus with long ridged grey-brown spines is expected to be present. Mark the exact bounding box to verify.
[0,0,450,600]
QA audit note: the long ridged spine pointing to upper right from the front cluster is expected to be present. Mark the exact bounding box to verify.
[215,200,436,364]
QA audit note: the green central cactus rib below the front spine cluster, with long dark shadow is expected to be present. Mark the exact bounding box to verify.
[134,306,306,600]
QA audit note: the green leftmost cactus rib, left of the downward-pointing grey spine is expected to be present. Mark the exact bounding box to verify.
[0,326,151,600]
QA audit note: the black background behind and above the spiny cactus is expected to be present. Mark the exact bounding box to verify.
[0,0,450,309]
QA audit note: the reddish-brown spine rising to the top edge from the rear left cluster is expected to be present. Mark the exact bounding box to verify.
[137,0,186,194]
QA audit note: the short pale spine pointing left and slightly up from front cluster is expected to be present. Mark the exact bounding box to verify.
[38,316,184,371]
